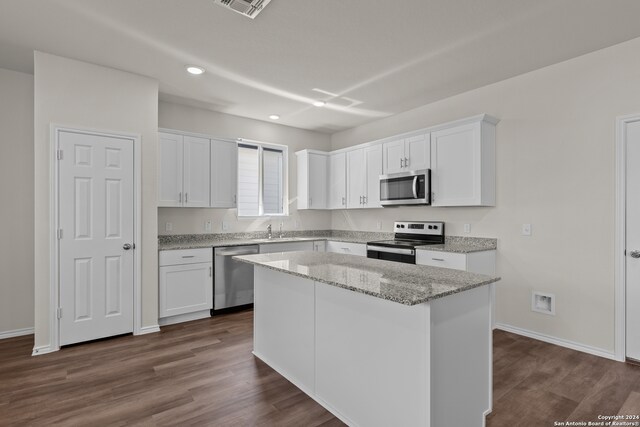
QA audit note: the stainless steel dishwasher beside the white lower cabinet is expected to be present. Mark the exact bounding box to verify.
[213,245,260,311]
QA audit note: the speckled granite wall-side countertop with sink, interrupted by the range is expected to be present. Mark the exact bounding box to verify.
[158,230,498,253]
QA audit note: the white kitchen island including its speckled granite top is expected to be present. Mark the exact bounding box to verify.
[237,252,499,427]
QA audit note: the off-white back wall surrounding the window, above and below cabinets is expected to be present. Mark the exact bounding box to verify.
[158,102,331,234]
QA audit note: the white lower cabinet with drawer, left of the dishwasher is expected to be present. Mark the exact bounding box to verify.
[159,248,213,324]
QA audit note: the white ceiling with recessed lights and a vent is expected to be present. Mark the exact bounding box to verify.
[0,0,640,133]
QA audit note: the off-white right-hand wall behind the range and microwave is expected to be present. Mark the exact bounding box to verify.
[332,39,640,352]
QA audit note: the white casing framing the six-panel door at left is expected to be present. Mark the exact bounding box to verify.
[45,123,144,355]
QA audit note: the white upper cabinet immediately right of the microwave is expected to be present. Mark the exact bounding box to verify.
[431,116,497,206]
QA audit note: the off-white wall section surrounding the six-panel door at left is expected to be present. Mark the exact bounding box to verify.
[34,52,158,347]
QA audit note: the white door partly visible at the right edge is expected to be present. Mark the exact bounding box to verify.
[626,121,640,360]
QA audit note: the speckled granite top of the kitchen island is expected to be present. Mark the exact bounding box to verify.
[234,252,500,305]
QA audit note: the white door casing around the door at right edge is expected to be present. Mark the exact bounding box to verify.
[614,114,640,361]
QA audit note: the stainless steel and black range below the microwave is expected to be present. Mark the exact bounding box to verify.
[367,221,444,264]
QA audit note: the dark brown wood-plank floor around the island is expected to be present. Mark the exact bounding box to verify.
[0,311,640,427]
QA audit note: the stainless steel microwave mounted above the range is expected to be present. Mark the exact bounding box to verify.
[380,169,431,207]
